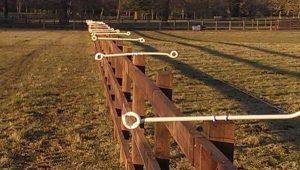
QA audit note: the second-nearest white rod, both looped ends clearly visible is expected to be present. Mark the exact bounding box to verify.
[95,51,178,60]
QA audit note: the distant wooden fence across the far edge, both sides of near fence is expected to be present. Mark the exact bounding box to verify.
[0,14,300,31]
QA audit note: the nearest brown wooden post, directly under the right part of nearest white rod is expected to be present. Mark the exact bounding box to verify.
[202,121,235,162]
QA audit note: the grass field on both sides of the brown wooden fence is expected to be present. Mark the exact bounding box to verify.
[0,30,300,169]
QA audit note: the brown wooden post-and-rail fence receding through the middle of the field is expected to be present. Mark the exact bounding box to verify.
[94,32,235,170]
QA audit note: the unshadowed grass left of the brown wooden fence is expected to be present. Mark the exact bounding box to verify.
[0,30,119,169]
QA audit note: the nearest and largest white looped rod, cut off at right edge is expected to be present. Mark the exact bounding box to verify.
[122,111,300,129]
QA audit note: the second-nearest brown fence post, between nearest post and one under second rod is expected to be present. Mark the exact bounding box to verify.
[154,71,173,170]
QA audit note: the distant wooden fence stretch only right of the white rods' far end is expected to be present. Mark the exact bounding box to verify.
[106,19,300,31]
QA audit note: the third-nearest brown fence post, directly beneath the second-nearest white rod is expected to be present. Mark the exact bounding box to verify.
[132,56,145,169]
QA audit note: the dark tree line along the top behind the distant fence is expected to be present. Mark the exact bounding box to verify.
[0,0,300,23]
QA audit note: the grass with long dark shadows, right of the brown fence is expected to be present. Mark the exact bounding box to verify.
[127,31,300,169]
